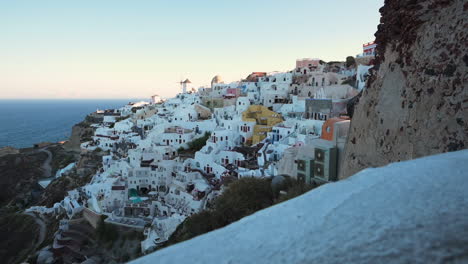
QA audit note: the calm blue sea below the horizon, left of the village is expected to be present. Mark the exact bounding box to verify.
[0,99,141,148]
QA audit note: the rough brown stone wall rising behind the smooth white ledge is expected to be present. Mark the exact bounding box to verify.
[340,0,468,178]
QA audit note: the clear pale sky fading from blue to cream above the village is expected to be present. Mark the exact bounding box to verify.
[0,0,383,99]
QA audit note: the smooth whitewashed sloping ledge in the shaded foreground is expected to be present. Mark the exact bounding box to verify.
[132,150,468,264]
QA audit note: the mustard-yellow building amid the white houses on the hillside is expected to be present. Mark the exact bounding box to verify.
[242,105,283,145]
